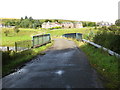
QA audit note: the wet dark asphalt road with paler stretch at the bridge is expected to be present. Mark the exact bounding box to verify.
[3,39,102,88]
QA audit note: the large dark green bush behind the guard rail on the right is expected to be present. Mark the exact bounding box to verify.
[93,31,120,54]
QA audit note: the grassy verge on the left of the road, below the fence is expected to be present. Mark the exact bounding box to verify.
[2,41,53,76]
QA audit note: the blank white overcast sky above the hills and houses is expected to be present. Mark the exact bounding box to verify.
[0,0,120,23]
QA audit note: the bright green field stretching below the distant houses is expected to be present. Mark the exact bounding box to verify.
[2,28,97,46]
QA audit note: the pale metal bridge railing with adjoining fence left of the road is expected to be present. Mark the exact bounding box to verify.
[15,34,51,52]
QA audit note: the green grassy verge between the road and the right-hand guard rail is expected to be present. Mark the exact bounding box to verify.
[74,40,120,88]
